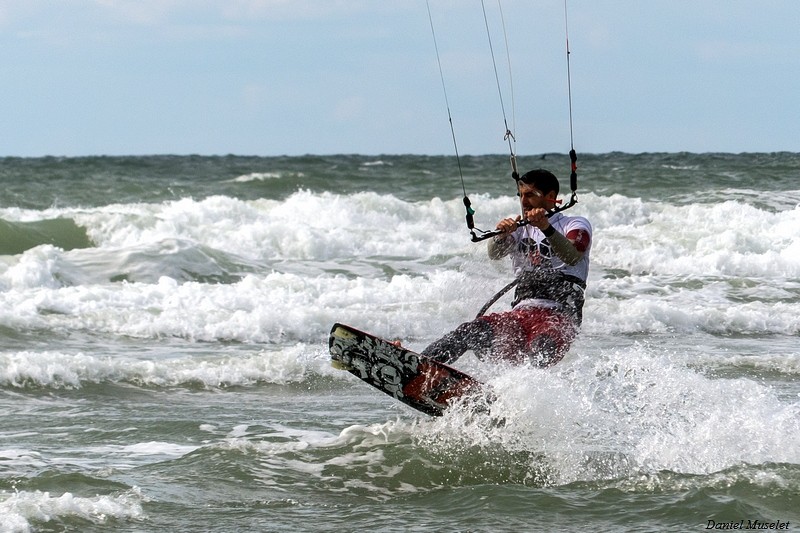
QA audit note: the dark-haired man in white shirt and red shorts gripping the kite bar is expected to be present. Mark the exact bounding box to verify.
[422,169,592,367]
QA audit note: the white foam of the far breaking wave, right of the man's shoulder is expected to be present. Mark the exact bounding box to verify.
[589,197,800,279]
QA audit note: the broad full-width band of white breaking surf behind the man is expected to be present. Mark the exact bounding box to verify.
[0,191,800,344]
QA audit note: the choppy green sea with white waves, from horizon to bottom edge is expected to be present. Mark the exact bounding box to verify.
[0,153,800,532]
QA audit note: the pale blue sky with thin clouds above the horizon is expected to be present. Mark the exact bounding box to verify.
[0,0,800,157]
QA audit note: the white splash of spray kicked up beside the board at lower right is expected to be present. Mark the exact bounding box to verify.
[425,347,800,484]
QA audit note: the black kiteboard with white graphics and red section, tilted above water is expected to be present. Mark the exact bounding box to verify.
[328,323,493,416]
